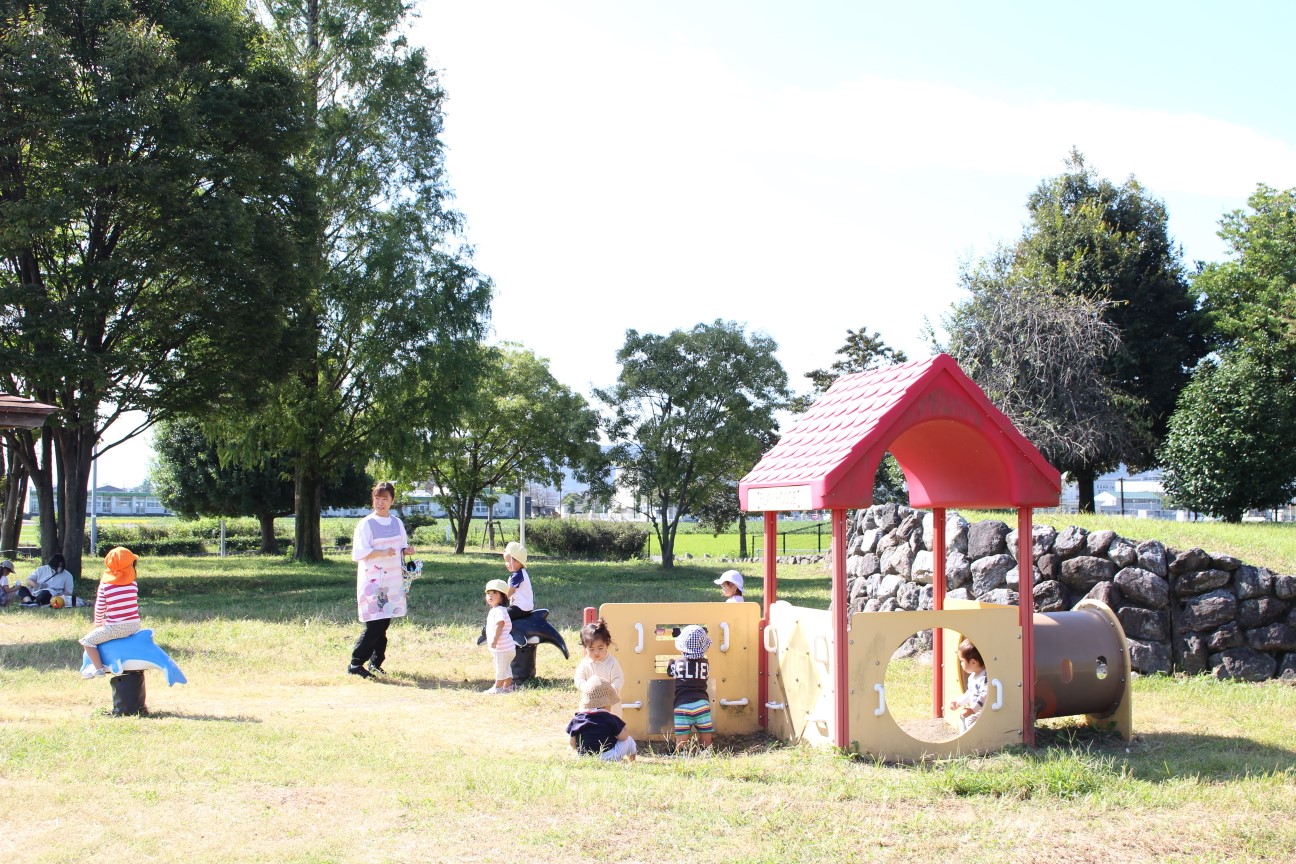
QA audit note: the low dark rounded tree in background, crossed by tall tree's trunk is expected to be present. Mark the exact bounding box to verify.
[149,417,372,554]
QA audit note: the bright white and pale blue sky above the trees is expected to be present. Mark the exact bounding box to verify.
[100,0,1296,486]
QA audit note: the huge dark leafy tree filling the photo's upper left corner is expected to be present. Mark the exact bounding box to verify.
[0,0,303,569]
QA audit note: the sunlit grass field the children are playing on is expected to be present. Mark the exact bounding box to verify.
[0,556,1296,864]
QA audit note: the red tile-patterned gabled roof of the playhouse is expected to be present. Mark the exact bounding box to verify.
[739,354,1061,510]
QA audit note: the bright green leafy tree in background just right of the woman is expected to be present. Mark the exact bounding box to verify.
[404,345,601,553]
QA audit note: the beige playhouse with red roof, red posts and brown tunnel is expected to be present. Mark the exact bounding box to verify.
[586,355,1131,760]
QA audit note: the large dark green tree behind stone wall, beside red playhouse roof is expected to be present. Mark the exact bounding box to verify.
[946,152,1208,512]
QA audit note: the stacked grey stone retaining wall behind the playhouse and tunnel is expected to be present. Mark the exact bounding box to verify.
[846,504,1296,683]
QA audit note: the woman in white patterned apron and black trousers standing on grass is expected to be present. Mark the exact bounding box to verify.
[346,482,413,677]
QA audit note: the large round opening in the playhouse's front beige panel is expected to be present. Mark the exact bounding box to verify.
[883,630,976,742]
